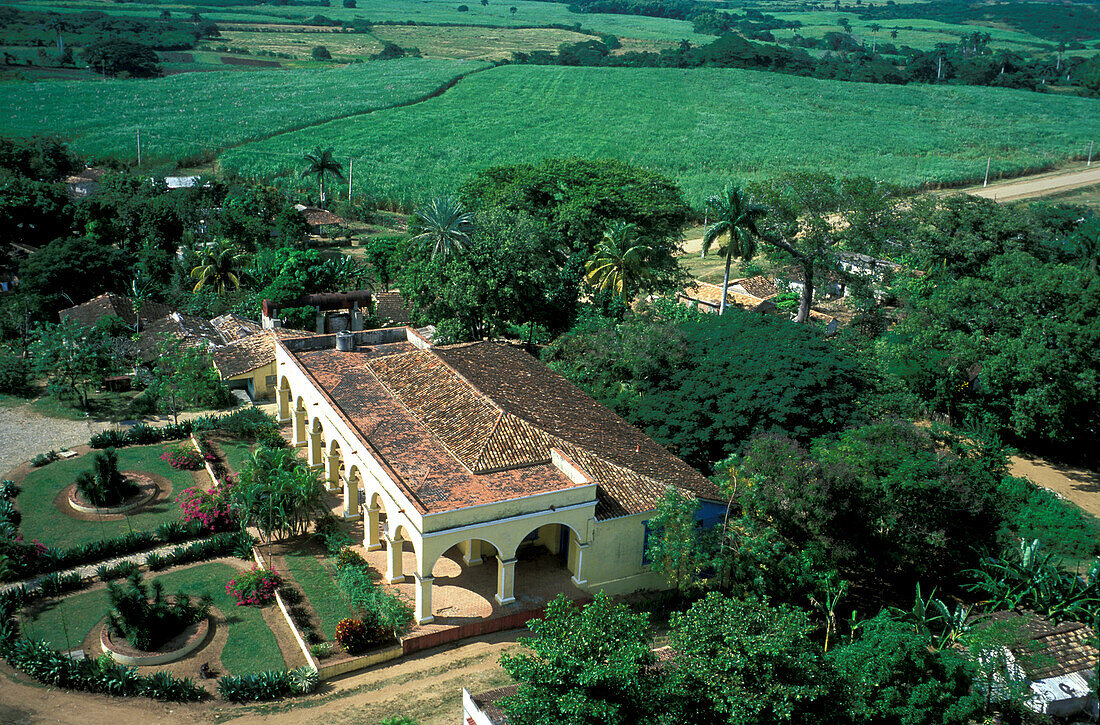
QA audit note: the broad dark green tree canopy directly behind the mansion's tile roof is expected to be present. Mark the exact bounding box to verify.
[545,309,868,470]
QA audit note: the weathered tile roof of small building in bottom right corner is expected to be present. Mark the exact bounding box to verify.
[990,611,1100,680]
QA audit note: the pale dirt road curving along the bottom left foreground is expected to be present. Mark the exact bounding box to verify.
[0,631,523,725]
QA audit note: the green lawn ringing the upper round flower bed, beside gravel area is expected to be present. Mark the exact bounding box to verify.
[15,442,195,548]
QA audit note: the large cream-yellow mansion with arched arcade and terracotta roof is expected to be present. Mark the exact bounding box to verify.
[275,328,725,624]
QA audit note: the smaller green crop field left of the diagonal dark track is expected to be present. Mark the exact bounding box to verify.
[0,58,485,163]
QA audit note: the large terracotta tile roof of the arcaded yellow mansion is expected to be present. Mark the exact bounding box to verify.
[284,342,721,518]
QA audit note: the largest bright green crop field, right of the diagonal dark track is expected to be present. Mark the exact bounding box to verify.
[221,66,1100,204]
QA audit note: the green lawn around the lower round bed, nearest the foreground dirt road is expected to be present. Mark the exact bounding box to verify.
[24,562,286,674]
